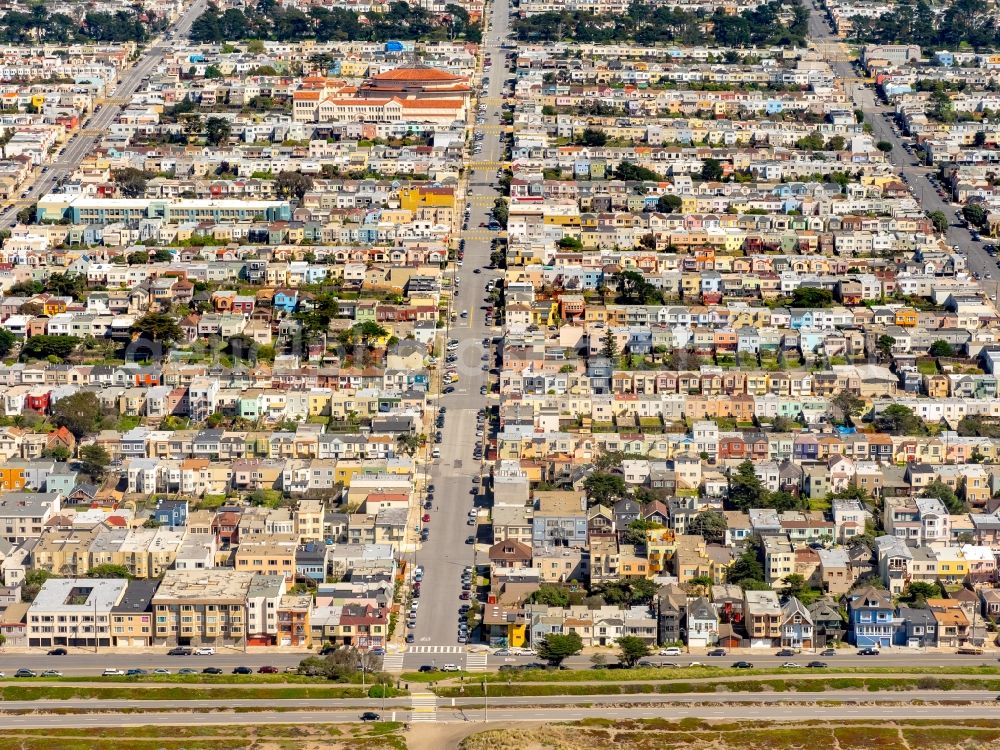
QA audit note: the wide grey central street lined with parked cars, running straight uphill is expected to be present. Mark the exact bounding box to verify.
[404,0,509,669]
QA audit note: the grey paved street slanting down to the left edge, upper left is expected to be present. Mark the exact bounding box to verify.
[0,0,207,228]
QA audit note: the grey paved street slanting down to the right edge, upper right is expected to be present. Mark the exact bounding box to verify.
[809,5,1000,299]
